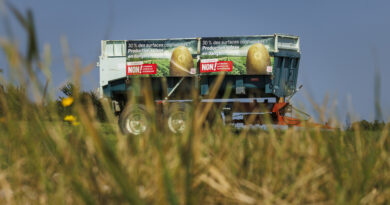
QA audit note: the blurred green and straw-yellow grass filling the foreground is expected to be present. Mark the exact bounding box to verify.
[0,4,390,204]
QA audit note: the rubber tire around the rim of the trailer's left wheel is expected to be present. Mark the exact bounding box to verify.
[118,105,151,136]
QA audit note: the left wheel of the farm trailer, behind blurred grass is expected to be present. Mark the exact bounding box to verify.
[119,105,150,135]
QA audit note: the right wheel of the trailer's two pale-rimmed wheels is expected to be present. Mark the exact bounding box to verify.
[167,103,190,133]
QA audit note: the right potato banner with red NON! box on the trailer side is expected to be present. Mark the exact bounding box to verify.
[199,36,275,75]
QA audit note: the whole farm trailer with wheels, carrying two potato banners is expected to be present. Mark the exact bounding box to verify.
[98,34,301,135]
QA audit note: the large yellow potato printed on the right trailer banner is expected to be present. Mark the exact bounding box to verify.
[246,43,271,75]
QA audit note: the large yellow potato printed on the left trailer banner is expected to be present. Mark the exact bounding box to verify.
[169,46,194,76]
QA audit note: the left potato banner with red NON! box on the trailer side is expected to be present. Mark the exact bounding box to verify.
[126,38,198,77]
